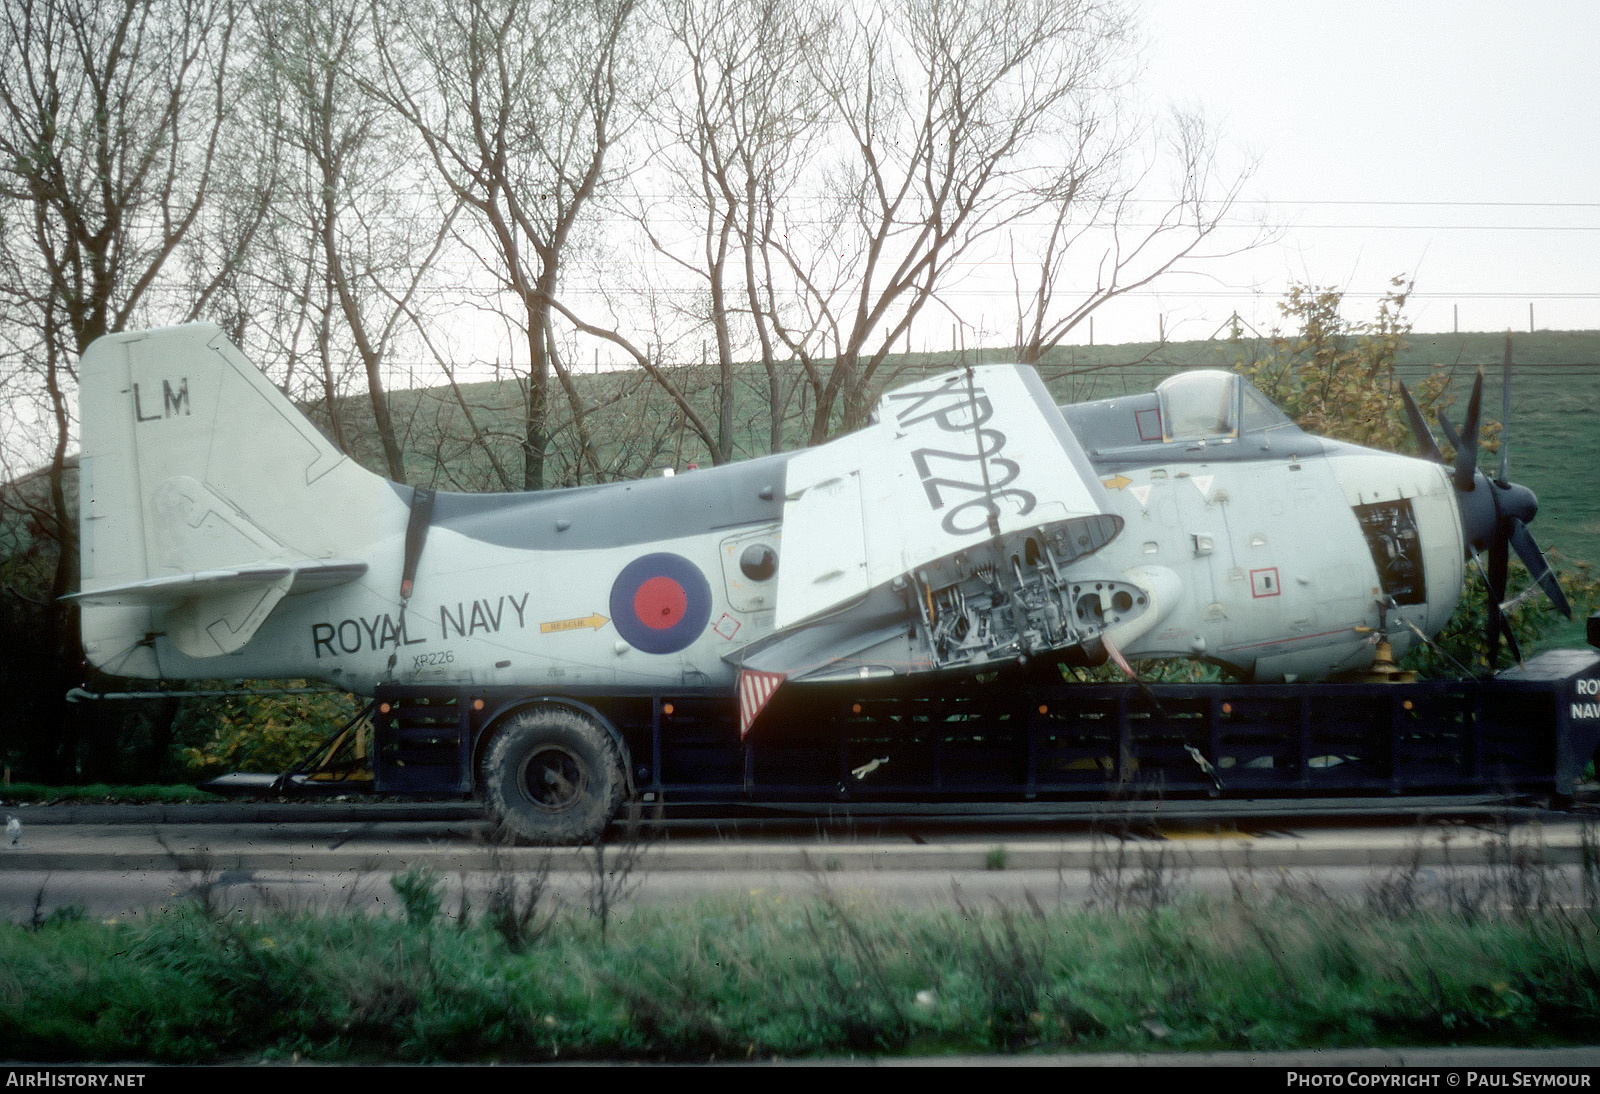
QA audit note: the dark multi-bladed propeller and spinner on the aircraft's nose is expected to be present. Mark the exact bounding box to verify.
[1400,334,1573,672]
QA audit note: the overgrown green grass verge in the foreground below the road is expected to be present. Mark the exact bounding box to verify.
[9,840,1600,1064]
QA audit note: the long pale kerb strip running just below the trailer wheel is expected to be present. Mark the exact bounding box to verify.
[0,824,1594,875]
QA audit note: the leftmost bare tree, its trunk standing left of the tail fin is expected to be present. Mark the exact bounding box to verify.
[0,0,250,776]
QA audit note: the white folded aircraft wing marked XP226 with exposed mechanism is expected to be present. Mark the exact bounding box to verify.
[730,365,1147,729]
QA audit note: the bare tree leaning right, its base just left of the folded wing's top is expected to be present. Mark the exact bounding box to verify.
[757,0,1128,443]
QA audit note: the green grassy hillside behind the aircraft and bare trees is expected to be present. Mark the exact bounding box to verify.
[349,331,1600,572]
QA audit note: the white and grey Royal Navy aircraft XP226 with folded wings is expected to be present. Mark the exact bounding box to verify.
[68,325,1565,831]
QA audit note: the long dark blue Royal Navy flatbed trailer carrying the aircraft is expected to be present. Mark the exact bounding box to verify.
[363,648,1600,841]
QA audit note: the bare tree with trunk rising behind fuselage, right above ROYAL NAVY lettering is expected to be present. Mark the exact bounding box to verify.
[374,0,635,489]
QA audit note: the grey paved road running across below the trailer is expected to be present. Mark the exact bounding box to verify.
[0,805,1595,921]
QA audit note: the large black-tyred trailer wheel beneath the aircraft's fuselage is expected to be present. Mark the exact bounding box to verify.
[483,707,622,844]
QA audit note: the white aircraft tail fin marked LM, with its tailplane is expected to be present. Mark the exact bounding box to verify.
[74,325,405,677]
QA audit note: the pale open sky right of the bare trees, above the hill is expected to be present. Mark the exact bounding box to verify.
[1080,0,1600,342]
